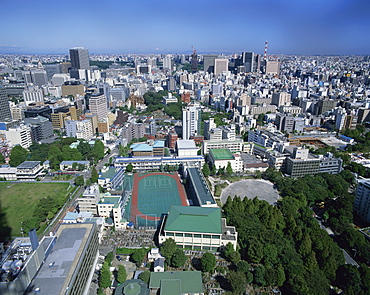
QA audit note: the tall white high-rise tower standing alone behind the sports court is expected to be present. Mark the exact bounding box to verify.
[182,104,201,140]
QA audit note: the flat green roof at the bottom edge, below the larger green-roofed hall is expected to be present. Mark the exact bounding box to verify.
[149,271,204,295]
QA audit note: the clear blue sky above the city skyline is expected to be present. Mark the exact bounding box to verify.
[0,0,370,55]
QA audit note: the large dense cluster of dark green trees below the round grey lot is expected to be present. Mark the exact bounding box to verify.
[223,196,344,294]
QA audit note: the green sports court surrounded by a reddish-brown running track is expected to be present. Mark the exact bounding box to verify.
[126,173,188,226]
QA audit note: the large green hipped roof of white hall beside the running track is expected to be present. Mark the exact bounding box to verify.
[164,206,222,234]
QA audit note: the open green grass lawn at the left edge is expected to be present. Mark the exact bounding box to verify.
[0,182,73,236]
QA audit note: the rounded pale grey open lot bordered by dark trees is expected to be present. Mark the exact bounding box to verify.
[221,179,279,205]
